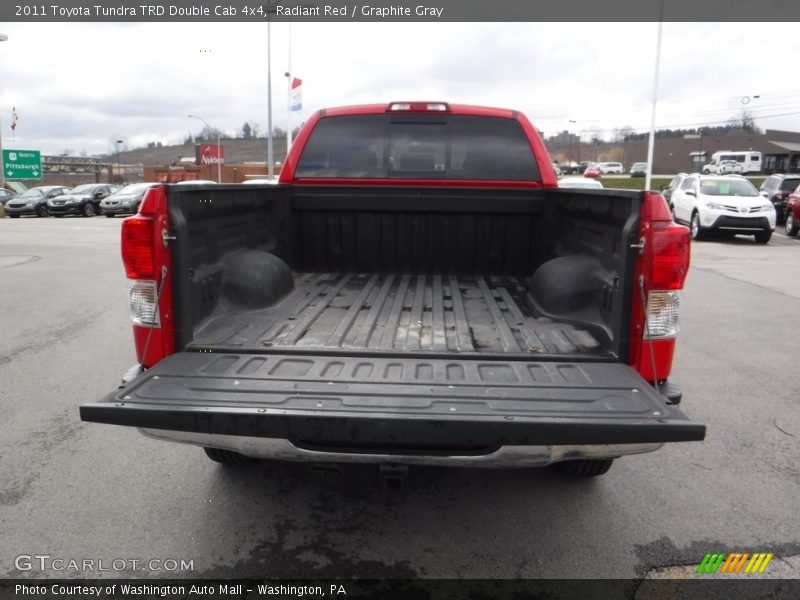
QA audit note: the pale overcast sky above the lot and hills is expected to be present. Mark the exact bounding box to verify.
[0,22,800,154]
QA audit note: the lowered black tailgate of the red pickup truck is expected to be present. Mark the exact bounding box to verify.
[80,352,705,447]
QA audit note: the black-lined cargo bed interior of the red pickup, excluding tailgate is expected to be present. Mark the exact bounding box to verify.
[169,186,639,361]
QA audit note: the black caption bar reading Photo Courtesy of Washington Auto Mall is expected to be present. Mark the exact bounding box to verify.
[0,576,800,600]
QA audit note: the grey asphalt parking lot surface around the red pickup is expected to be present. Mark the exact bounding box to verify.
[0,218,800,578]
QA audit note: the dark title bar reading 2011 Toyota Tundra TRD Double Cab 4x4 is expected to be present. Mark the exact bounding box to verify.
[0,0,800,22]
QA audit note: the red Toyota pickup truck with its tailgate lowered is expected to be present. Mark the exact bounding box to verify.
[80,102,705,477]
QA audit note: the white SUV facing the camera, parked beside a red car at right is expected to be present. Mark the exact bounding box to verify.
[671,173,775,244]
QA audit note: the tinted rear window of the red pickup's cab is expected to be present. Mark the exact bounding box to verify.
[295,114,540,181]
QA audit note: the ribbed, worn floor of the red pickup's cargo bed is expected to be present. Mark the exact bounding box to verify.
[191,273,605,356]
